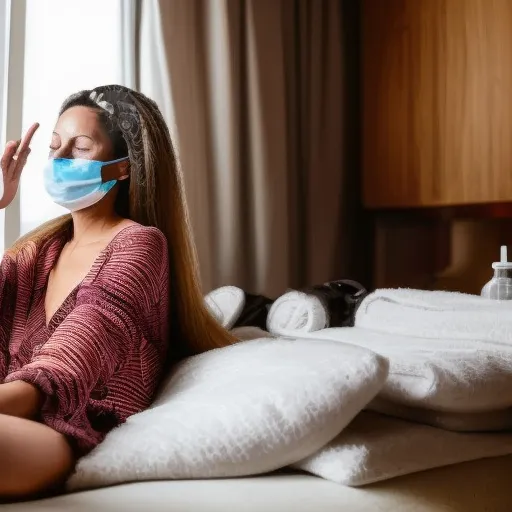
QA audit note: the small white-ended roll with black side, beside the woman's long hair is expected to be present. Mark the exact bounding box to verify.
[205,286,273,330]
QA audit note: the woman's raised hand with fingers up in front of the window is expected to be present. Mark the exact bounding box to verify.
[0,123,39,210]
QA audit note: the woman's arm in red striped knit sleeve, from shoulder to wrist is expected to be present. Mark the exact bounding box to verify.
[0,230,168,438]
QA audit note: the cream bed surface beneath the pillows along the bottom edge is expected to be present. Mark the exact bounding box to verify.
[6,456,512,512]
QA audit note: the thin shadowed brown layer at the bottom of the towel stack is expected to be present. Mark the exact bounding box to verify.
[366,397,512,432]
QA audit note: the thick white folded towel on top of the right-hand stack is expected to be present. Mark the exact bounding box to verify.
[355,289,512,343]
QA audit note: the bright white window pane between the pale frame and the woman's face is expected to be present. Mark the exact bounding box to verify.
[19,0,123,234]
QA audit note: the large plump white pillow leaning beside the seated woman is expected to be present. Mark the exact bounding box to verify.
[68,338,387,490]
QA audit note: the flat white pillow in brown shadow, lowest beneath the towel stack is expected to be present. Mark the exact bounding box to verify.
[292,412,512,486]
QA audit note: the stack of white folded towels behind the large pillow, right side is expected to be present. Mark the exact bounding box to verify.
[280,289,512,432]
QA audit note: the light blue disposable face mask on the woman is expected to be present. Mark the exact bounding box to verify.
[44,157,128,212]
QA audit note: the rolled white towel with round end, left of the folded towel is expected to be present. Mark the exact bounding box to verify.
[267,291,329,335]
